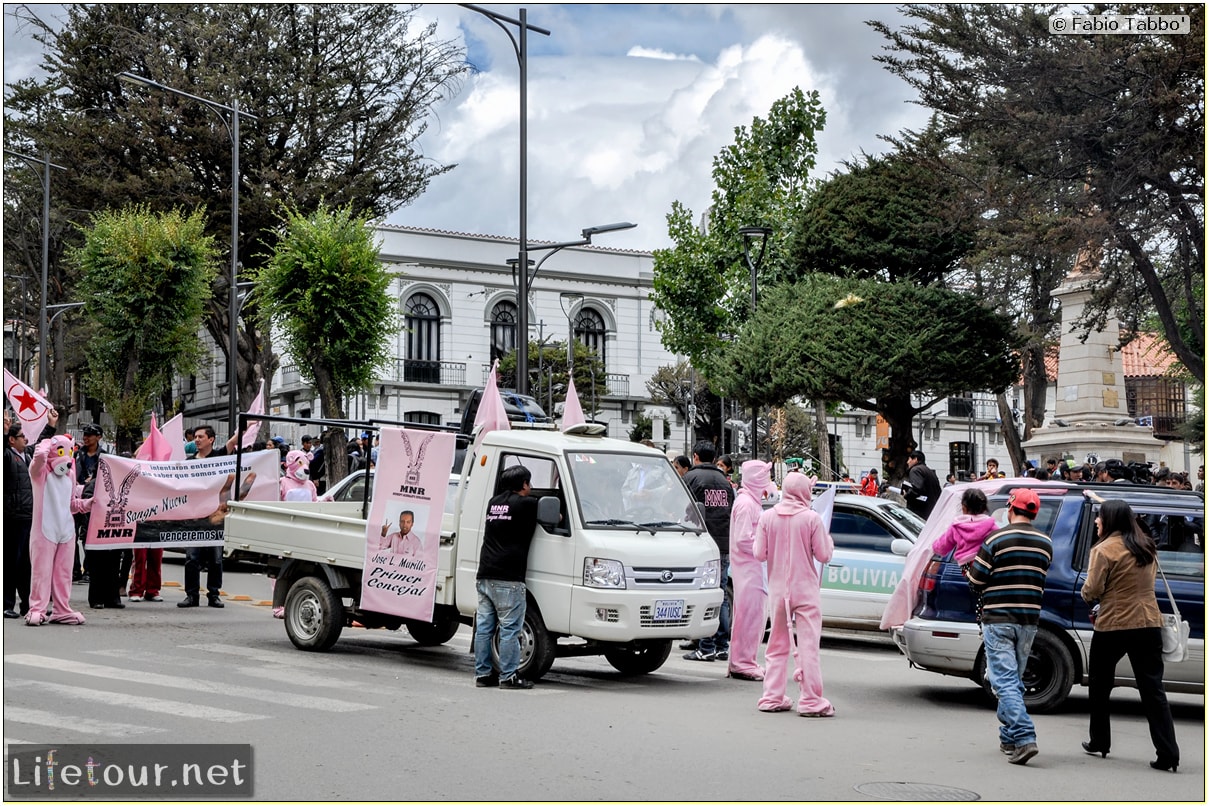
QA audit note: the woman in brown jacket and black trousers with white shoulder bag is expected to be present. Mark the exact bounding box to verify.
[1082,500,1180,772]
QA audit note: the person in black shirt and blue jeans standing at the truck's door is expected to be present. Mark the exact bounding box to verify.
[474,465,537,689]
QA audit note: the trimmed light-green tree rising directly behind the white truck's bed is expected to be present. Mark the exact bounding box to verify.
[251,204,400,483]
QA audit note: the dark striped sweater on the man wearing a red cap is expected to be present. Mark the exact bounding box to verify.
[970,523,1053,625]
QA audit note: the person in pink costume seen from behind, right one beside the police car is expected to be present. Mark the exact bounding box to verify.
[753,472,835,717]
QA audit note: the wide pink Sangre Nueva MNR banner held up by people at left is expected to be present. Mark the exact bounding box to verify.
[85,451,282,549]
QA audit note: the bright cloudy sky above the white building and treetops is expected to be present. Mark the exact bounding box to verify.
[4,4,926,250]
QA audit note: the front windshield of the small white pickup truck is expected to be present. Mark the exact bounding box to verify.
[567,451,705,532]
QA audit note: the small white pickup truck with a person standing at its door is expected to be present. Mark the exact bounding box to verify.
[226,424,723,679]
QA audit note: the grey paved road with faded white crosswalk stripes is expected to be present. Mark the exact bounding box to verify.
[4,561,1205,801]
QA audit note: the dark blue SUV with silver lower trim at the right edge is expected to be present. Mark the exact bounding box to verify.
[891,479,1205,713]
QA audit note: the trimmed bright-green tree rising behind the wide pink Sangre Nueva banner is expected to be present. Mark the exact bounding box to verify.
[68,205,218,451]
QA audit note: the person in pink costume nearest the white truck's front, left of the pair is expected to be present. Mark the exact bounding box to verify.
[727,459,777,680]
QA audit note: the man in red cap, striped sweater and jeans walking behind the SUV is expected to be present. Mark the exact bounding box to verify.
[970,488,1053,764]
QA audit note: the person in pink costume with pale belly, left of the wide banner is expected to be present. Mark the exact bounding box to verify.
[25,434,92,627]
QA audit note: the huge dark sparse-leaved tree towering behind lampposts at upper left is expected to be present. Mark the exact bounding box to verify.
[5,4,469,425]
